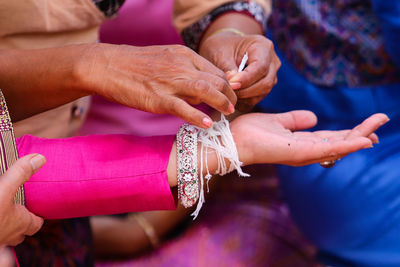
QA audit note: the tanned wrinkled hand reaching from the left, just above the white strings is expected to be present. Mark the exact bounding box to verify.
[80,44,236,128]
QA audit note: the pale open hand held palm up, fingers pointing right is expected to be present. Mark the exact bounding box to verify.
[231,110,389,166]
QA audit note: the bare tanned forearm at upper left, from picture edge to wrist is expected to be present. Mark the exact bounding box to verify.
[0,45,91,122]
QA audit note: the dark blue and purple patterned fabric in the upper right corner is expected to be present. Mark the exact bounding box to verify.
[269,0,400,87]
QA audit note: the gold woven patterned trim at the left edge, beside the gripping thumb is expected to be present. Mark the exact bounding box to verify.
[0,90,25,205]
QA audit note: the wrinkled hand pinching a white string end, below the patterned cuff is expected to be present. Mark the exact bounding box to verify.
[199,32,281,111]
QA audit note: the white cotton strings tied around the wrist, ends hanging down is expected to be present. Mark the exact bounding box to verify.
[191,114,250,220]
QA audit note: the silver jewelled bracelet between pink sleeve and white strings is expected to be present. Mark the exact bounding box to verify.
[176,124,199,208]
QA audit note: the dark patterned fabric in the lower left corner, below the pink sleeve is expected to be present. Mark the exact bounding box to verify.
[15,218,94,267]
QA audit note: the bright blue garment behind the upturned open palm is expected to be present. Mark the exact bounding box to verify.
[258,0,400,267]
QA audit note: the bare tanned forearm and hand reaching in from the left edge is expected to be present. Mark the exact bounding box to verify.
[0,44,236,128]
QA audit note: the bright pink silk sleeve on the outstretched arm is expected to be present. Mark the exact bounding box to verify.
[16,135,175,219]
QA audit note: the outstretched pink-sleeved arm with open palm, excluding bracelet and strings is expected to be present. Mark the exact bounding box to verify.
[18,111,388,219]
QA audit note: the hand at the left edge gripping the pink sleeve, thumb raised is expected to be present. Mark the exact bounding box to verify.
[0,154,46,246]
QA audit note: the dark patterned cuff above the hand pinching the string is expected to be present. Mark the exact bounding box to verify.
[182,1,268,50]
